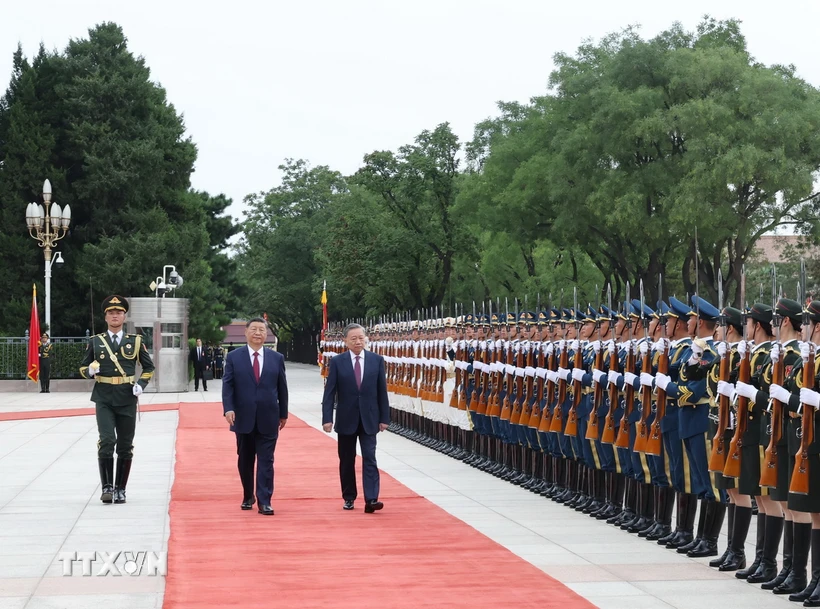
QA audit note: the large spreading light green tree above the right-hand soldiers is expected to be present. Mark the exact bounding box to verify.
[462,18,820,300]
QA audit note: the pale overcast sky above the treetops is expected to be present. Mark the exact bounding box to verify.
[0,0,820,223]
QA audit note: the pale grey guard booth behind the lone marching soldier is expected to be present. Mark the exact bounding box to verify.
[126,298,188,393]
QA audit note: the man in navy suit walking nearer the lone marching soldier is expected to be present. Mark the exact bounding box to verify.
[222,317,288,516]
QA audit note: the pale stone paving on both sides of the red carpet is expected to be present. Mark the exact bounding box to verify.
[0,364,797,609]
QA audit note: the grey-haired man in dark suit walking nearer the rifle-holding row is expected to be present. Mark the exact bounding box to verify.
[322,324,390,514]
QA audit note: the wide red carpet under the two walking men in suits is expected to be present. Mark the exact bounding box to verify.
[164,404,594,609]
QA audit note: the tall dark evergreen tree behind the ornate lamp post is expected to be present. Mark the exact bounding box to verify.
[0,23,235,339]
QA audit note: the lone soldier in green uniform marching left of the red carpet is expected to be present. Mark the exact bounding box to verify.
[80,296,154,503]
